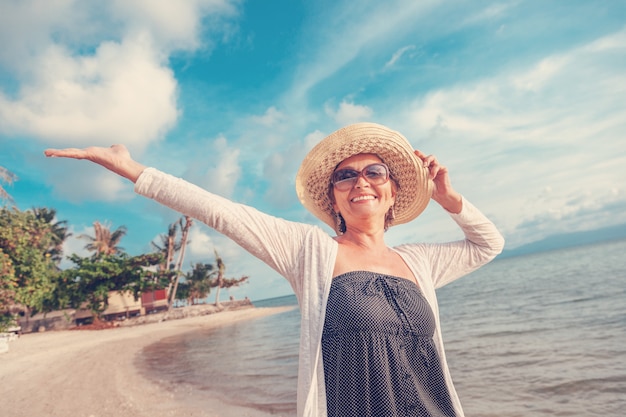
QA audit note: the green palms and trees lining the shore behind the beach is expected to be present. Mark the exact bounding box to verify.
[0,202,248,331]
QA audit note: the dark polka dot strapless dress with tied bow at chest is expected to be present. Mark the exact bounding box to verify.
[322,271,455,417]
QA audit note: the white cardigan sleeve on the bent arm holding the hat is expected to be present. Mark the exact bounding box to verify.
[400,198,504,288]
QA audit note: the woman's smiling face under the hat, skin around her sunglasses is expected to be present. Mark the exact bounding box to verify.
[333,154,396,224]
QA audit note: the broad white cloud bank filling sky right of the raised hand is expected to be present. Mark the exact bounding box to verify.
[392,26,626,247]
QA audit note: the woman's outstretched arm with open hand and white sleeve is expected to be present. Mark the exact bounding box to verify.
[45,145,316,288]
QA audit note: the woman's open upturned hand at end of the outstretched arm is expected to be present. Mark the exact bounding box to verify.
[44,145,146,182]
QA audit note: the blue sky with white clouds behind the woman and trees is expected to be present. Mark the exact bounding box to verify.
[0,0,626,300]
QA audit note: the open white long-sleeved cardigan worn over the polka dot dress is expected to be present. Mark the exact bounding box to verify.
[135,168,504,417]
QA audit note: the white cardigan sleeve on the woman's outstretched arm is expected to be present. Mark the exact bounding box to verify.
[135,168,312,287]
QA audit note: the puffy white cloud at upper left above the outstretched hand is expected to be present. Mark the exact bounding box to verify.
[0,34,178,150]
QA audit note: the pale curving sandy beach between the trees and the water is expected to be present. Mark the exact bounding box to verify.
[0,307,290,417]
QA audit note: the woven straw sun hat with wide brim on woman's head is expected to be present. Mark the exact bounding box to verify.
[296,123,433,230]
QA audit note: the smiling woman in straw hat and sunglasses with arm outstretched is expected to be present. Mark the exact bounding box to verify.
[46,123,503,417]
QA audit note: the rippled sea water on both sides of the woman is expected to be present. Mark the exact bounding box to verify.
[137,240,626,417]
